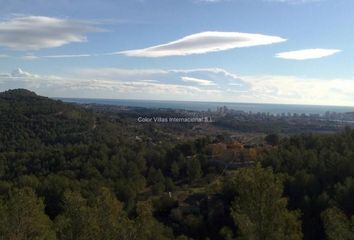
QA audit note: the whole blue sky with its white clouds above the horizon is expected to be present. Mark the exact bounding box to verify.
[0,0,354,106]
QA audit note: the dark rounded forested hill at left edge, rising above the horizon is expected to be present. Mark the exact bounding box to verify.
[0,89,94,151]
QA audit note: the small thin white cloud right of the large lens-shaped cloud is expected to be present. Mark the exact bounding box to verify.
[275,48,341,60]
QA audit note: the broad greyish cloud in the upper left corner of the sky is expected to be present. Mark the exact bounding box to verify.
[0,16,99,50]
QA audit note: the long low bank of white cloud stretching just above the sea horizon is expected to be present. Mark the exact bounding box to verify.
[0,68,354,106]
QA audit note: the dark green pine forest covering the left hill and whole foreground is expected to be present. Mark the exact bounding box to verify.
[0,89,354,240]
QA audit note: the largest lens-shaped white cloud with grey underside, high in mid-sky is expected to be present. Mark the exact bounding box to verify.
[117,32,286,57]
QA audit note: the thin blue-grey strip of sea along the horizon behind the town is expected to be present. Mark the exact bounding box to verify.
[56,98,354,115]
